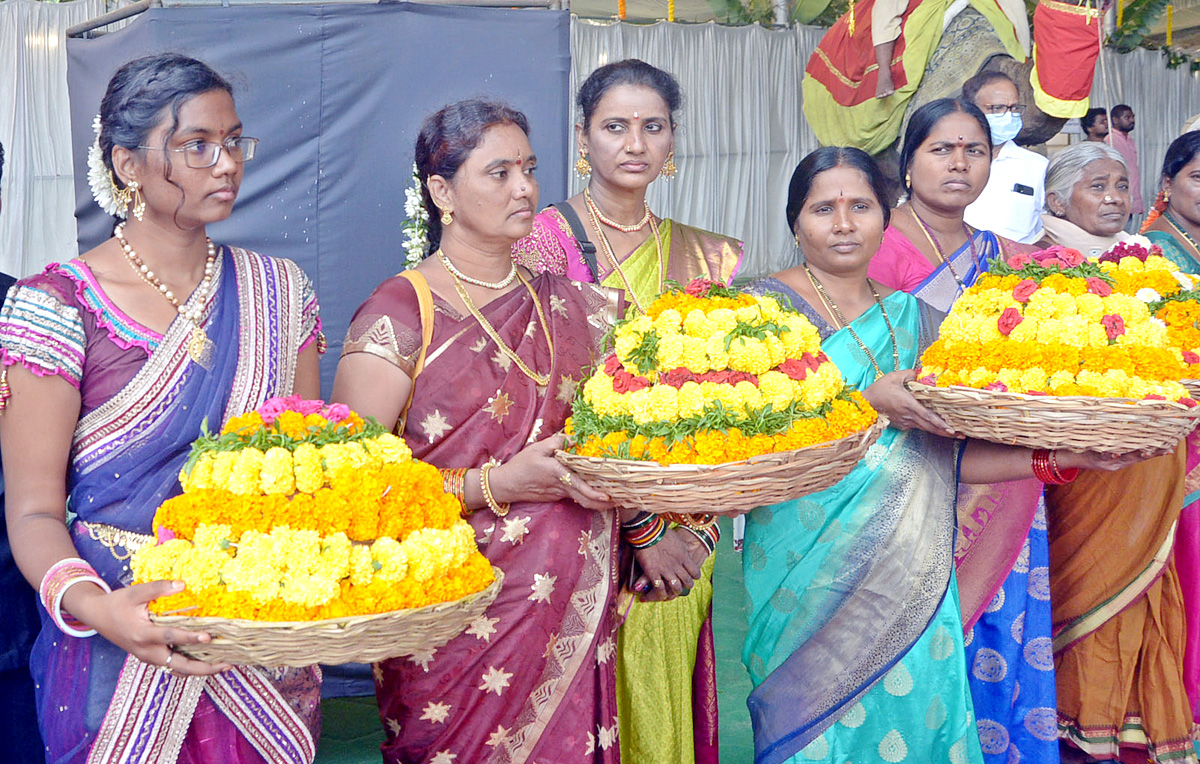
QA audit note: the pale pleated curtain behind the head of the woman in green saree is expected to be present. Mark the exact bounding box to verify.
[571,19,824,276]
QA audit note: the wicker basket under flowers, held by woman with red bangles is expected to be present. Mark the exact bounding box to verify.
[908,383,1200,453]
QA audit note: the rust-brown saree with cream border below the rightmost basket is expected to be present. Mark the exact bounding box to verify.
[1046,445,1196,762]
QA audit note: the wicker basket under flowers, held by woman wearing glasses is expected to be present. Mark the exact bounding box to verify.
[151,567,504,667]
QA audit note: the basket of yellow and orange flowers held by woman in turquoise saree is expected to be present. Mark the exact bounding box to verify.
[911,242,1200,452]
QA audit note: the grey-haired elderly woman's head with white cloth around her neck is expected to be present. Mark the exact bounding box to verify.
[1039,140,1129,258]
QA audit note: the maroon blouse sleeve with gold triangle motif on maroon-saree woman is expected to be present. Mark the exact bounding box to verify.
[342,276,421,378]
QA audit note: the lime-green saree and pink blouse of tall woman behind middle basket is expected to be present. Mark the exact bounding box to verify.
[514,207,742,764]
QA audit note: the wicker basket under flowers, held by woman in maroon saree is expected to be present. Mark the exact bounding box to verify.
[554,416,887,515]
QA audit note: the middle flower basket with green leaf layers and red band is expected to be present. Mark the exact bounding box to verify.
[560,279,881,512]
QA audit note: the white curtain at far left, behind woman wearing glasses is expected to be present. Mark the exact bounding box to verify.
[0,0,104,276]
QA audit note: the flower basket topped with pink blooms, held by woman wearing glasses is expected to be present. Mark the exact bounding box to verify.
[131,397,498,664]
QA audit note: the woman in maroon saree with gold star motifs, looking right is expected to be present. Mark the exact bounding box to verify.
[334,101,619,764]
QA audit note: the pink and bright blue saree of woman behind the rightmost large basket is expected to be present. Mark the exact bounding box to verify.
[871,227,1058,764]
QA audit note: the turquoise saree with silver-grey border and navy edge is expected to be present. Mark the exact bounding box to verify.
[743,291,982,764]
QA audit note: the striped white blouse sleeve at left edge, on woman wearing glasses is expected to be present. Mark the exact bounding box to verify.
[0,272,86,390]
